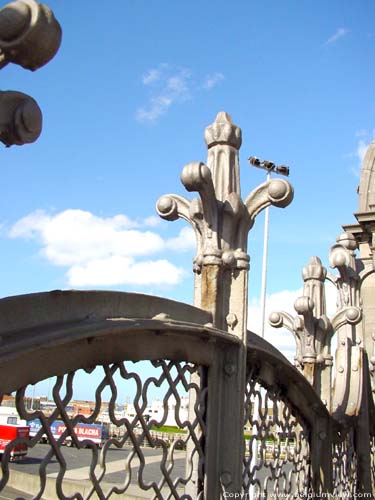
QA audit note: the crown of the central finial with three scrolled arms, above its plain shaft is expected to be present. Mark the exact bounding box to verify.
[156,112,293,273]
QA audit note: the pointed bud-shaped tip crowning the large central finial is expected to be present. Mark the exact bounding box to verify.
[204,111,242,149]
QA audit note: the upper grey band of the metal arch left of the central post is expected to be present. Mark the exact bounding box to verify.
[0,290,212,337]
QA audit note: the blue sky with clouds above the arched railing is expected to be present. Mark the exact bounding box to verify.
[0,0,375,398]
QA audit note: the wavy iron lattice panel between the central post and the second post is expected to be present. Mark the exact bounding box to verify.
[243,370,311,500]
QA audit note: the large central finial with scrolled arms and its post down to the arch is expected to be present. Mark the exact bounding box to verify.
[157,112,293,336]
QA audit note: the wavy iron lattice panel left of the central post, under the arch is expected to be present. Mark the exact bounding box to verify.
[0,360,206,500]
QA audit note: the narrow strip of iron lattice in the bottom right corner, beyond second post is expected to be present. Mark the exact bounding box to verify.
[332,429,360,498]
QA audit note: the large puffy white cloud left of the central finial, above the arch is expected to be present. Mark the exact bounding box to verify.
[9,209,194,286]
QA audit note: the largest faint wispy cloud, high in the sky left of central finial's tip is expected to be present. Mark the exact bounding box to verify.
[136,65,191,123]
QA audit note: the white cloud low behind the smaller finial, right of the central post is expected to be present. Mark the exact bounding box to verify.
[248,283,336,363]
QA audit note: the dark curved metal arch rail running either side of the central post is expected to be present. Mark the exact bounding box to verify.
[0,291,328,434]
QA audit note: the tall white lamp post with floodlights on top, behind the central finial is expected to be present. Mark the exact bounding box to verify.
[248,156,289,500]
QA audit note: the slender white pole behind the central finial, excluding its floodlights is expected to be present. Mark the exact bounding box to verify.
[250,172,271,500]
